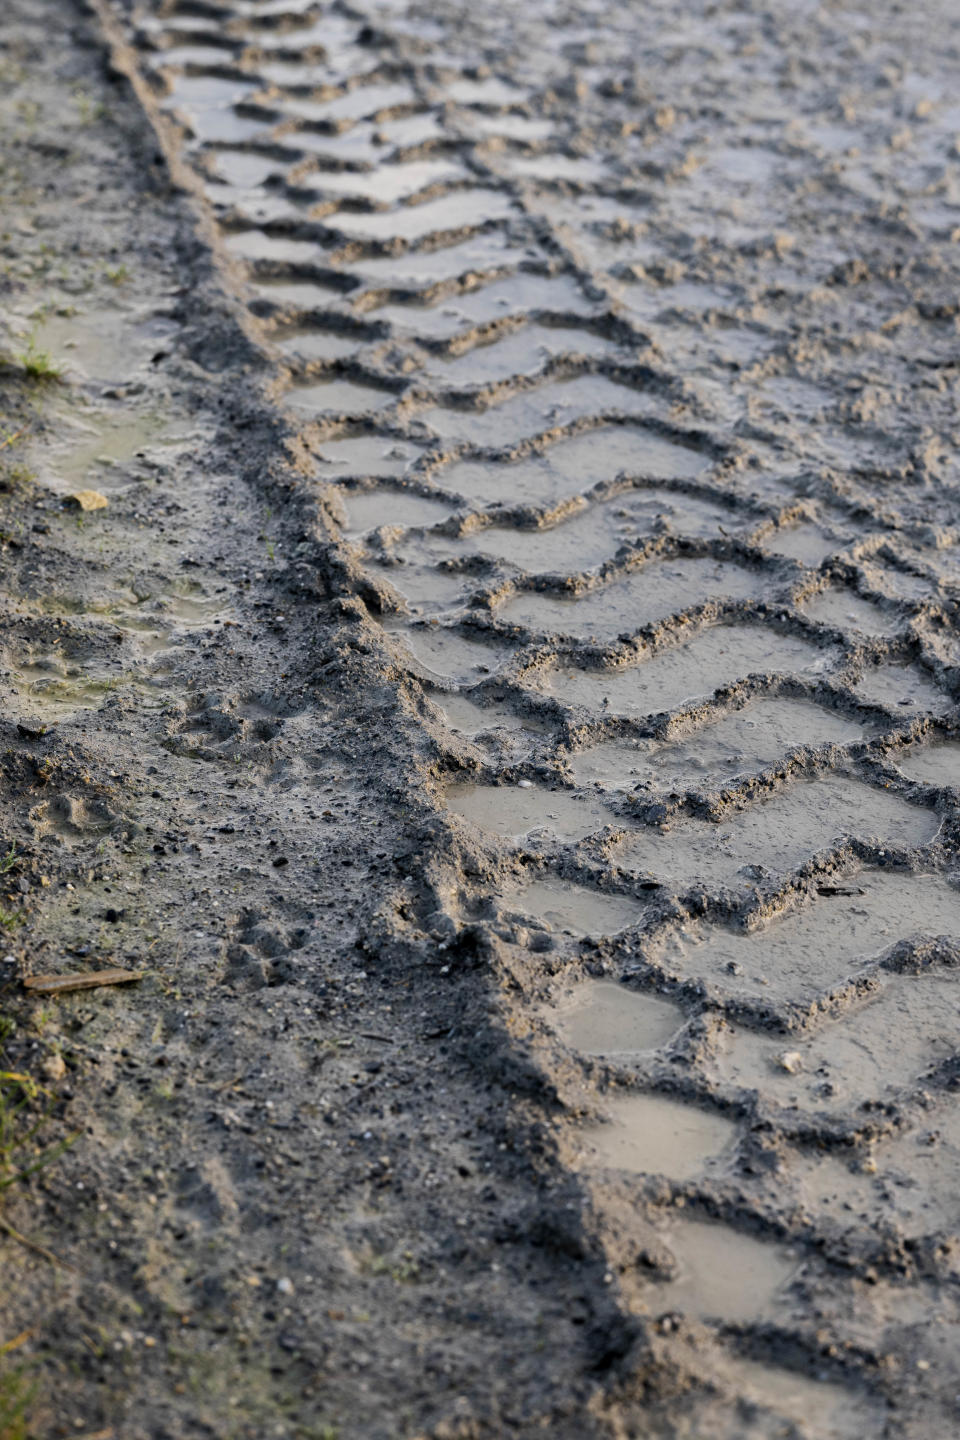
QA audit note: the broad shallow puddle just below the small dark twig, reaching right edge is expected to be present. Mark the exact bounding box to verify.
[662,870,960,1002]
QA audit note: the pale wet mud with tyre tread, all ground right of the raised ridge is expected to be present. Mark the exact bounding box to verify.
[11,0,960,1440]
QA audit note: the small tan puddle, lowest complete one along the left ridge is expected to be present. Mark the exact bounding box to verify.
[638,1220,799,1323]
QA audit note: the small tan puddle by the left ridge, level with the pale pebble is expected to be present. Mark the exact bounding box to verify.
[543,979,684,1056]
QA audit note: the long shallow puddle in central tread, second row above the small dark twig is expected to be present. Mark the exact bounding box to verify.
[570,698,866,789]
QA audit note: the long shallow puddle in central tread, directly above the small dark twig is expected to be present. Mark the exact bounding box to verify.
[620,775,940,890]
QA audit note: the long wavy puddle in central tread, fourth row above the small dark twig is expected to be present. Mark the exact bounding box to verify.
[498,559,770,641]
